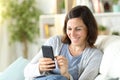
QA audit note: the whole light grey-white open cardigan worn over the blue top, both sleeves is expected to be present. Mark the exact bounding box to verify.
[24,36,103,80]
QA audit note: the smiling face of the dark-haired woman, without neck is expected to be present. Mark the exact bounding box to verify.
[67,18,87,46]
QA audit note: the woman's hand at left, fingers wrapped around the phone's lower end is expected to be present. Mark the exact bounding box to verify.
[39,58,55,72]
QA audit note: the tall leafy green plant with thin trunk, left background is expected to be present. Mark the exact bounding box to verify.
[2,0,41,58]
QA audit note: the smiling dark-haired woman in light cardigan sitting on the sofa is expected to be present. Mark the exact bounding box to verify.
[24,6,102,80]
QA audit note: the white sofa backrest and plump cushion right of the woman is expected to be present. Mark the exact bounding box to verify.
[96,35,120,80]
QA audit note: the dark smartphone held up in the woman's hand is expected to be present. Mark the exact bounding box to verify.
[42,45,54,60]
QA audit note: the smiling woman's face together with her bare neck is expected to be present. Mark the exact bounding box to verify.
[67,18,87,56]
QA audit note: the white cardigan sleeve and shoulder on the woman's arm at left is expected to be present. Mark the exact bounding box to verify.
[24,36,61,78]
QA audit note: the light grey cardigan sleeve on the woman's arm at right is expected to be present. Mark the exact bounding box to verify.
[79,51,102,80]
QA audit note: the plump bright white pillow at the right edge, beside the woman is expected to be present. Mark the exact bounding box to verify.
[100,40,120,78]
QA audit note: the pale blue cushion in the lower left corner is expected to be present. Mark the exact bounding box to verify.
[0,57,28,80]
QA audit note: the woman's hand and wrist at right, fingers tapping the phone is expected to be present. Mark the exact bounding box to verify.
[56,56,70,80]
